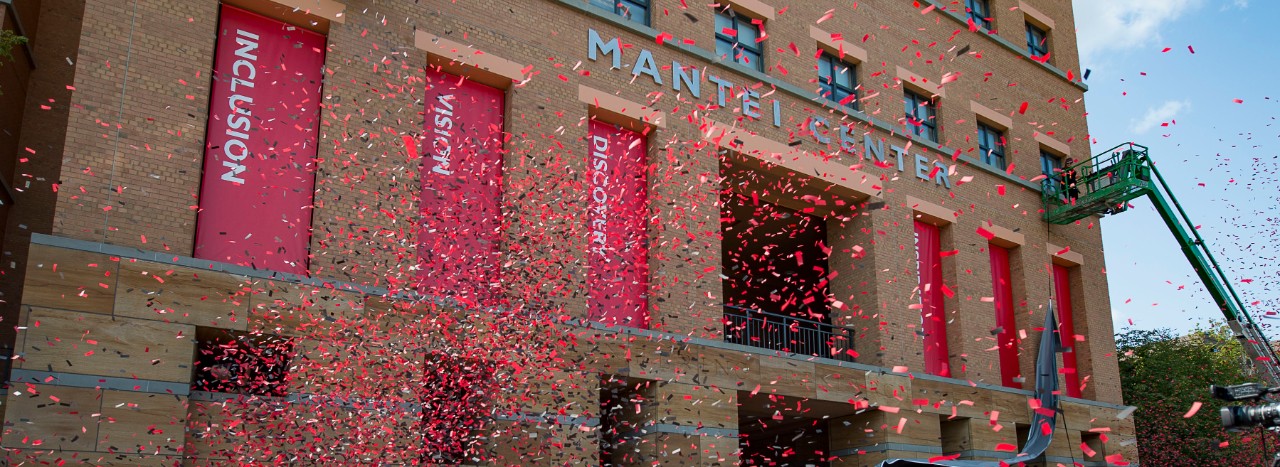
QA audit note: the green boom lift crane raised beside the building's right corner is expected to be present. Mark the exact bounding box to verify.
[1041,143,1280,386]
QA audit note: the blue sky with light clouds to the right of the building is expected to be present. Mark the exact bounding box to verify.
[1073,0,1280,338]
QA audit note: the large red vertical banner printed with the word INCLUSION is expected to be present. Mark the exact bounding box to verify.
[193,5,325,274]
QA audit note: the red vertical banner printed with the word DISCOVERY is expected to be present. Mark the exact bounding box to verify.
[586,120,649,329]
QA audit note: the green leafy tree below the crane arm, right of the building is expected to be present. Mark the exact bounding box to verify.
[1116,324,1277,467]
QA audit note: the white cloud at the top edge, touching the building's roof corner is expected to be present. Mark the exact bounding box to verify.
[1073,0,1203,64]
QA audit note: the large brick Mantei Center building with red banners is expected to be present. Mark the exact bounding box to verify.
[0,0,1137,466]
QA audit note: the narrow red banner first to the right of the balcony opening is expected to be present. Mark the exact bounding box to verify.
[915,220,951,376]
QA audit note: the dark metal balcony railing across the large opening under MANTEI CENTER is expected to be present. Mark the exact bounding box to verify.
[724,305,854,362]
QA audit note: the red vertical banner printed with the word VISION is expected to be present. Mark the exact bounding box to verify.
[417,69,507,305]
